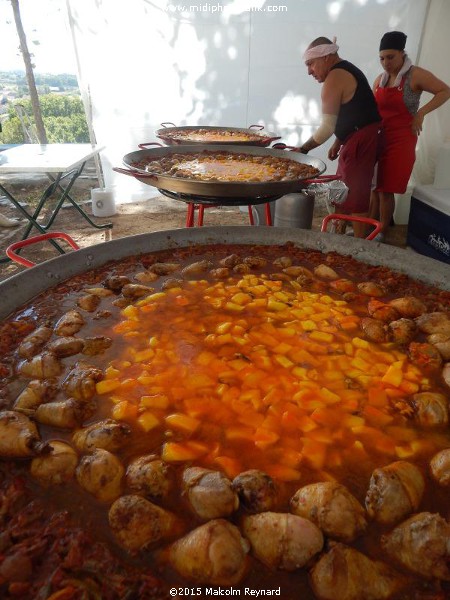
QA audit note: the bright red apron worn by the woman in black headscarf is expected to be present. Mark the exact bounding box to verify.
[375,78,417,194]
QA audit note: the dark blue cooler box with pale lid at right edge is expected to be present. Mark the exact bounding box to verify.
[407,185,450,264]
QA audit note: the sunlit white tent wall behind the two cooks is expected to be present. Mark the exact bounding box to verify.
[67,0,442,202]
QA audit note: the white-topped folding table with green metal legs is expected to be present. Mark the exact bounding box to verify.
[0,144,113,262]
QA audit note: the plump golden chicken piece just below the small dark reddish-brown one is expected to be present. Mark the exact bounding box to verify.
[242,512,323,571]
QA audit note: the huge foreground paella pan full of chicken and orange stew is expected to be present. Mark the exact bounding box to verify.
[0,227,450,600]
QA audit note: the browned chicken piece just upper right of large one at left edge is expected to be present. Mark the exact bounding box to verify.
[33,398,96,429]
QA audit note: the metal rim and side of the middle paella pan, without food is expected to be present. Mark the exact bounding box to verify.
[114,144,326,199]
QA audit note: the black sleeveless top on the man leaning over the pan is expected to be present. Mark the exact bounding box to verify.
[331,60,381,142]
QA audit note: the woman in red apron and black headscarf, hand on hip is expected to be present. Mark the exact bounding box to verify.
[370,31,450,240]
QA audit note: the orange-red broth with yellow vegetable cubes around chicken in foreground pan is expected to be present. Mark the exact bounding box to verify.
[0,245,450,600]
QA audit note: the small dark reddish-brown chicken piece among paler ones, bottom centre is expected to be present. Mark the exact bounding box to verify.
[232,469,277,513]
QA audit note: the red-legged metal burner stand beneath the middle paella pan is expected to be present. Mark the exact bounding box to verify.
[158,188,283,227]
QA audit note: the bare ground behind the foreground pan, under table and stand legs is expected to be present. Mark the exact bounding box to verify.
[0,179,406,281]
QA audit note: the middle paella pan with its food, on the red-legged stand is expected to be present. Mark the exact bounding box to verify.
[114,145,326,199]
